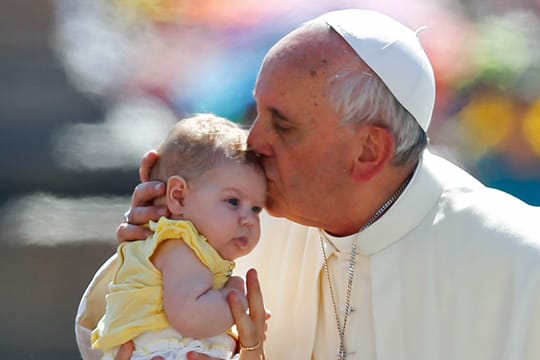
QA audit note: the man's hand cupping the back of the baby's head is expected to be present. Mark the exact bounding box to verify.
[116,150,170,242]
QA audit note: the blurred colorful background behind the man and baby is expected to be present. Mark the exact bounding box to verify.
[0,0,540,360]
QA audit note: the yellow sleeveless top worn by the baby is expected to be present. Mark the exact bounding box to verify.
[92,217,234,350]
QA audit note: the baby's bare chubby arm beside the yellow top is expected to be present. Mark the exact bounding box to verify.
[152,240,233,338]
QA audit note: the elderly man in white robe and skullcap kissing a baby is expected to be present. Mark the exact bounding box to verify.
[77,10,540,360]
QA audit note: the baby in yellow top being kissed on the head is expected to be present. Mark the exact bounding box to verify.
[92,114,266,360]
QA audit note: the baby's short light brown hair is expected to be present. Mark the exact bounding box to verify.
[150,114,262,182]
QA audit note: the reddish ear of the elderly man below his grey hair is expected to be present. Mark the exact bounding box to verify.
[353,126,395,181]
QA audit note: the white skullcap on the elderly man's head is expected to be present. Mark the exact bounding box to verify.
[319,9,435,131]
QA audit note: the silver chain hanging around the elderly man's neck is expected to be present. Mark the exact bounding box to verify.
[319,178,410,360]
